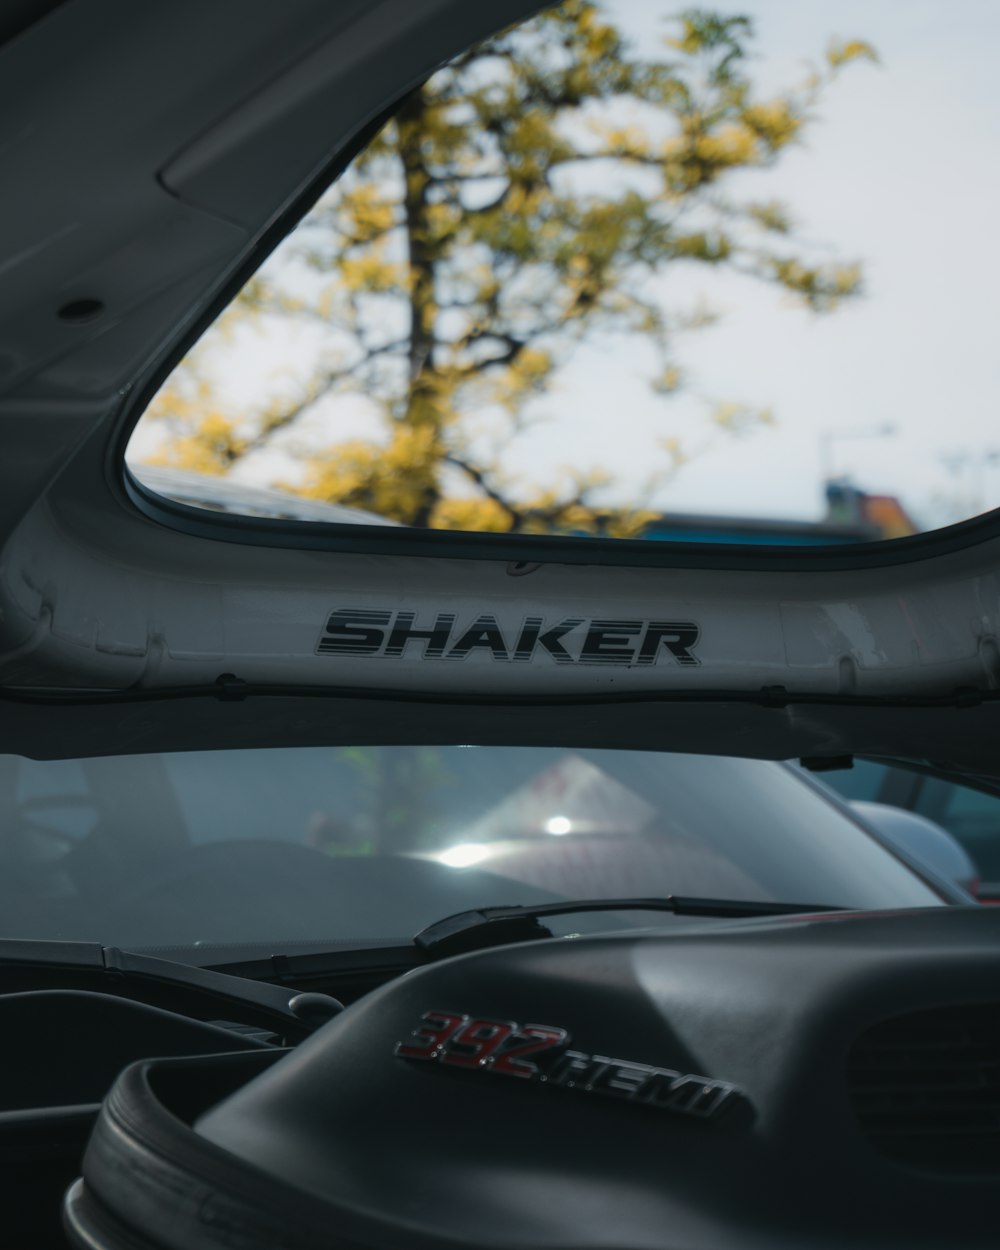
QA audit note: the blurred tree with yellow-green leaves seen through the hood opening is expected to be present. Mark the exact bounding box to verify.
[140,0,875,534]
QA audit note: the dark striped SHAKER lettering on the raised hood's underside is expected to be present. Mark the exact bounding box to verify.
[316,608,700,666]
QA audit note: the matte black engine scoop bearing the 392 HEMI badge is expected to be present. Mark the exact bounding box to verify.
[68,908,1000,1250]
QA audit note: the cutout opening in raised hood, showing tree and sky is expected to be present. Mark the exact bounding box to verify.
[129,0,1000,544]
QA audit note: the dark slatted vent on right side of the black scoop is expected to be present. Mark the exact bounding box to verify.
[848,1003,1000,1174]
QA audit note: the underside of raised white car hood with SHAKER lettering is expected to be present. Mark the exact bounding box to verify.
[0,0,1000,776]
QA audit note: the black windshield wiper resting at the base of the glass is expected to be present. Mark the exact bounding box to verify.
[414,894,844,958]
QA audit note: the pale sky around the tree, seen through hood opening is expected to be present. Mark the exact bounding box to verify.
[126,0,1000,528]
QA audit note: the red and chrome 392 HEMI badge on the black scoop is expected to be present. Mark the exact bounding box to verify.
[395,1011,744,1119]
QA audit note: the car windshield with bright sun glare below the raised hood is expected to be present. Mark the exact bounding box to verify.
[0,746,941,963]
